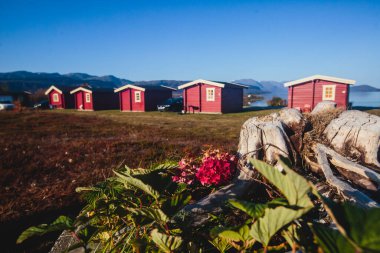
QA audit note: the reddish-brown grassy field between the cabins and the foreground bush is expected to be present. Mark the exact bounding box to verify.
[0,107,380,252]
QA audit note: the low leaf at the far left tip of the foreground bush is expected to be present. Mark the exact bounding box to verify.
[16,216,74,244]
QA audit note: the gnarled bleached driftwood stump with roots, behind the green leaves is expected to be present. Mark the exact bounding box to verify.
[184,103,380,226]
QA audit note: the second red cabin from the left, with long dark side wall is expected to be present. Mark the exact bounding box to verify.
[70,86,119,111]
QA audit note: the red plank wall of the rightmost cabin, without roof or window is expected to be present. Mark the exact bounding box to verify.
[288,80,349,110]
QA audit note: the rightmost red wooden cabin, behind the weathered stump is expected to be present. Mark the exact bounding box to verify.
[284,75,355,112]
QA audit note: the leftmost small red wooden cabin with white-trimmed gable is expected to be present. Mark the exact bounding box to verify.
[45,85,75,109]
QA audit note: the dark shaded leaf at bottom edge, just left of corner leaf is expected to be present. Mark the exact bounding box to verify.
[312,223,355,253]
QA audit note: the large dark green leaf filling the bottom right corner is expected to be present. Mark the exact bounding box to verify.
[322,198,380,251]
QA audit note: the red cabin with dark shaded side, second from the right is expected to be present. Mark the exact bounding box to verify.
[178,79,247,113]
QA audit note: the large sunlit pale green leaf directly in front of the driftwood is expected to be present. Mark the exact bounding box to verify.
[250,159,313,208]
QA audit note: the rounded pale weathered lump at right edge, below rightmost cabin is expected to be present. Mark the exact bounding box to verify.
[324,111,380,168]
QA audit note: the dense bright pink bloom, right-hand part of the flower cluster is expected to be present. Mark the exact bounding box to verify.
[195,150,237,186]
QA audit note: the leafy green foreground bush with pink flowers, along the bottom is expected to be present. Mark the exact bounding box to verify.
[18,153,380,252]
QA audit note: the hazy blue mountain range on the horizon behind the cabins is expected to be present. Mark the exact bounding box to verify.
[0,71,380,95]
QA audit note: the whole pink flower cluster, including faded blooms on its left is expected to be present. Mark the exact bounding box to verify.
[172,148,237,186]
